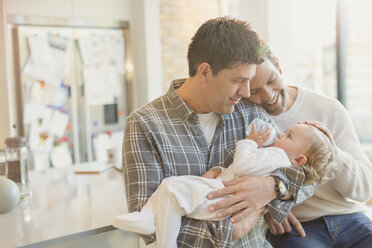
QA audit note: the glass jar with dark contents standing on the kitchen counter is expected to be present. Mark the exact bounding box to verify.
[5,137,31,198]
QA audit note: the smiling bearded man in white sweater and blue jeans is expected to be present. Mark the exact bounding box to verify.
[248,45,372,248]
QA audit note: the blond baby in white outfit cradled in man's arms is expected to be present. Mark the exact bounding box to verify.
[113,119,335,248]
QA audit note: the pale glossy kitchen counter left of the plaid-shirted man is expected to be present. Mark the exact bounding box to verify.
[0,166,139,248]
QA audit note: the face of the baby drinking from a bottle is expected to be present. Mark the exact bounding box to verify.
[272,124,314,161]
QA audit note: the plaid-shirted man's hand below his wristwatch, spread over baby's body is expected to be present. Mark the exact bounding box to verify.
[207,176,276,224]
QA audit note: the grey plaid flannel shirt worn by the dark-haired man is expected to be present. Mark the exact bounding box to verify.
[123,80,304,248]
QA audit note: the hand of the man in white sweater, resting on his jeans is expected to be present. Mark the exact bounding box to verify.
[264,212,306,238]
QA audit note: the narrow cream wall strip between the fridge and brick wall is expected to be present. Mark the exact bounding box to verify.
[131,0,163,109]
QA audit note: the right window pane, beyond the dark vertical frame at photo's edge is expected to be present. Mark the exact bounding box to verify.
[344,0,372,159]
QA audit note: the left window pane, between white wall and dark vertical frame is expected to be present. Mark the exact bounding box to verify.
[292,0,337,97]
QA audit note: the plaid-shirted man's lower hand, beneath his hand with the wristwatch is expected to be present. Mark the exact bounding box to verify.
[232,207,267,241]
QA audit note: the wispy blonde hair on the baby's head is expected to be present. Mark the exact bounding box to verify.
[302,126,337,184]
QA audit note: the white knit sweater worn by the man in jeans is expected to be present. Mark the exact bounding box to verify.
[272,87,372,221]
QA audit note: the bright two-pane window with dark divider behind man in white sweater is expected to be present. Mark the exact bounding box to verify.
[292,0,372,159]
